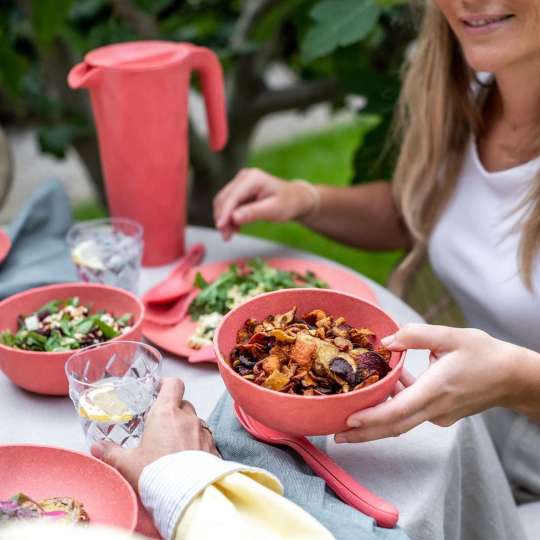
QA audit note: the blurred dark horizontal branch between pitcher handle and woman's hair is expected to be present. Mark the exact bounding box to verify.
[251,79,339,118]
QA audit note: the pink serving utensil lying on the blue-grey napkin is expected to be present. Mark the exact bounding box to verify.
[234,403,399,528]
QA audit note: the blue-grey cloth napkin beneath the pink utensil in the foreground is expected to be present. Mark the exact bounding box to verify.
[208,393,408,540]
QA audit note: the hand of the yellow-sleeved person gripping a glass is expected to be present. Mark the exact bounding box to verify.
[92,379,218,489]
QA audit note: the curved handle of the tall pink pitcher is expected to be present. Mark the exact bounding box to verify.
[188,47,228,152]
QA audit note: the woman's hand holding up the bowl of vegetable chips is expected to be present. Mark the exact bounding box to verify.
[335,324,523,443]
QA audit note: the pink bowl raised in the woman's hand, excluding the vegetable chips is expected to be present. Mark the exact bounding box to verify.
[214,289,404,435]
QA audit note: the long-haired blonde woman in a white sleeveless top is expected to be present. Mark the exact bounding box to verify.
[214,0,540,500]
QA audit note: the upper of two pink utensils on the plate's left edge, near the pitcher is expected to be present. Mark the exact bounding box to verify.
[143,244,206,305]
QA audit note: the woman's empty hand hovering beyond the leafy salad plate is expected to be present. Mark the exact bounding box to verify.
[214,169,318,240]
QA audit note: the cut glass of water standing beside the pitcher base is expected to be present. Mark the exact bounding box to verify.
[66,218,143,293]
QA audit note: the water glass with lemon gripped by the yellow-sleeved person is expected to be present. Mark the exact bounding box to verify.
[65,341,161,448]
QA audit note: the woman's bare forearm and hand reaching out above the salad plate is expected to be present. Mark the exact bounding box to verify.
[214,169,410,249]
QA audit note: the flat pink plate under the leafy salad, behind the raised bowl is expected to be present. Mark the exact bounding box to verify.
[143,258,377,361]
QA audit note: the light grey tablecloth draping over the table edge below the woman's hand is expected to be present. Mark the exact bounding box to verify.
[327,415,525,540]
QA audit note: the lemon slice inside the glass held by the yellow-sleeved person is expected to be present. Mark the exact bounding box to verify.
[78,384,133,424]
